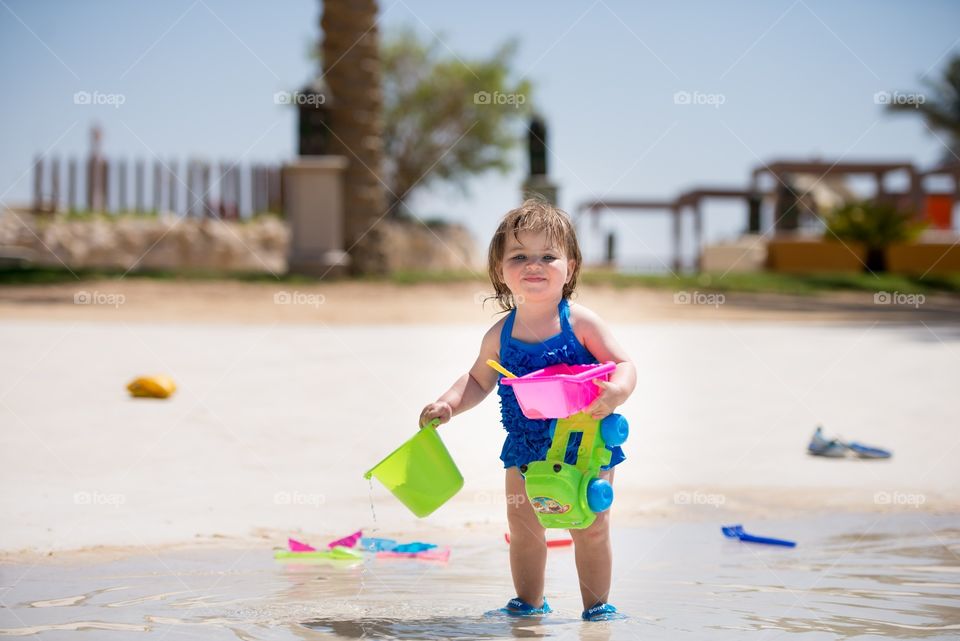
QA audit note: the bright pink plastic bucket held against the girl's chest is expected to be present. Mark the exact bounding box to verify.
[500,361,617,419]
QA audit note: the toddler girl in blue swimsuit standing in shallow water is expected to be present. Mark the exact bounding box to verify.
[420,199,636,620]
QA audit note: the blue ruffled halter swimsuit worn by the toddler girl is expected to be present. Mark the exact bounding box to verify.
[497,298,626,469]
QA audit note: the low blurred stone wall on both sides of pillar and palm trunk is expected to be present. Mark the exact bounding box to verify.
[0,210,478,274]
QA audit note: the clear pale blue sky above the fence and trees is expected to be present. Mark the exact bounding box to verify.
[0,0,960,270]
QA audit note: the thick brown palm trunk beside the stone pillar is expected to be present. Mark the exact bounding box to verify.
[320,0,386,274]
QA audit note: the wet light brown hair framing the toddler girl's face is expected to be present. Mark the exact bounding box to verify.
[487,198,583,312]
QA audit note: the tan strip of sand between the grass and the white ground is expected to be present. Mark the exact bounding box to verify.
[0,278,960,325]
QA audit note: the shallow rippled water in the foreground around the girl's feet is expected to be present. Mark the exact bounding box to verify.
[0,512,960,640]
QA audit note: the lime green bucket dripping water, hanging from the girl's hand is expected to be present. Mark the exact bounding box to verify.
[363,422,463,518]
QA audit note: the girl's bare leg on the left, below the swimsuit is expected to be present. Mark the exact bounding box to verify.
[506,467,547,608]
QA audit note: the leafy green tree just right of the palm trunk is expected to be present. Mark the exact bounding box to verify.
[333,29,532,215]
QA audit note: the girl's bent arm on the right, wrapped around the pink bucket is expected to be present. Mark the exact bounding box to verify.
[577,305,637,419]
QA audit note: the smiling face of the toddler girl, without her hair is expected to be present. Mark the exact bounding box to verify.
[500,231,576,303]
